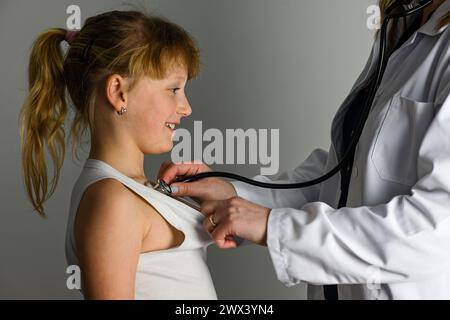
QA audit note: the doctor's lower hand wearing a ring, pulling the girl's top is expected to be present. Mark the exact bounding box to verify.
[200,197,271,249]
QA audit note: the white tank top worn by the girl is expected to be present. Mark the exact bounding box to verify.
[66,159,217,300]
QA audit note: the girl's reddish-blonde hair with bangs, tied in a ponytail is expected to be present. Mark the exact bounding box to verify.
[19,11,199,216]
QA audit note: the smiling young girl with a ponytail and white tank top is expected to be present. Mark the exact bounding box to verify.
[21,11,217,299]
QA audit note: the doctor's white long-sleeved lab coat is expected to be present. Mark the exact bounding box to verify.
[233,0,450,299]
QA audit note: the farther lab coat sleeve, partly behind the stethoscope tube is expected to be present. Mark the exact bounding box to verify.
[231,149,328,209]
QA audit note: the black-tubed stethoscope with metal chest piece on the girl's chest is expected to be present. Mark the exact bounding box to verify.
[154,0,433,199]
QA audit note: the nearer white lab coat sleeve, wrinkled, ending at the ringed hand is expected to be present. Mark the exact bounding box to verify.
[267,86,450,286]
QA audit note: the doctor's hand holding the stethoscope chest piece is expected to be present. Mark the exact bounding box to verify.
[158,161,237,203]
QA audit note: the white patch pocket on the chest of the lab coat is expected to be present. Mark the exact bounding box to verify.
[371,95,434,186]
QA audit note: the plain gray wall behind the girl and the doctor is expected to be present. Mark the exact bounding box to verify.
[0,0,375,299]
